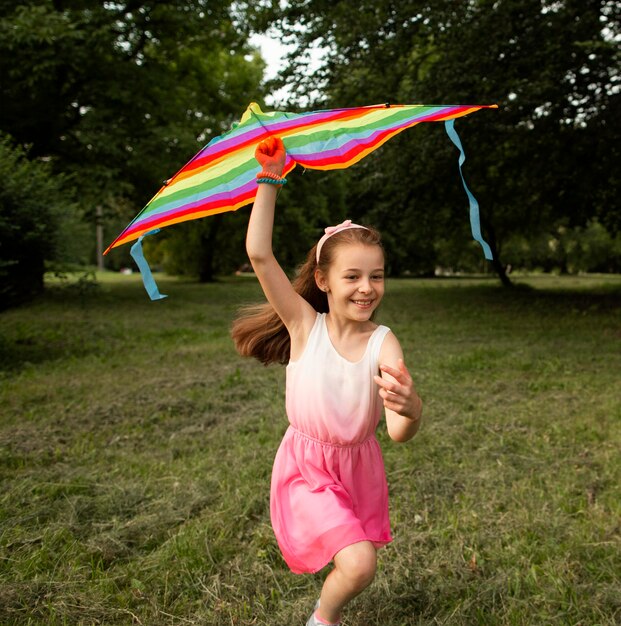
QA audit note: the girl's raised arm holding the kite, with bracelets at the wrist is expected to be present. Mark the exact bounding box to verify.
[246,137,317,346]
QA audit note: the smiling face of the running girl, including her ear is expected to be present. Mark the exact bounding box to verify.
[316,244,384,322]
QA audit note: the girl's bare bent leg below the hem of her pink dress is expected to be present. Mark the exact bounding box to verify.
[318,541,377,624]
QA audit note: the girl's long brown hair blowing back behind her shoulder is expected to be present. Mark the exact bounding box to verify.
[231,228,383,365]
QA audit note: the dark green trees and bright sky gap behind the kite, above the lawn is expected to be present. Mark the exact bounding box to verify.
[0,0,621,308]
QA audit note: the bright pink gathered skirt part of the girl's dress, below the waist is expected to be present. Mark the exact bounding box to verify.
[270,426,392,574]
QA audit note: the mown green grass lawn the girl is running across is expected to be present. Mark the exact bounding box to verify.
[0,276,621,626]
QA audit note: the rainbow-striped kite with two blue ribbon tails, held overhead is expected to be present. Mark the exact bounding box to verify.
[104,102,497,299]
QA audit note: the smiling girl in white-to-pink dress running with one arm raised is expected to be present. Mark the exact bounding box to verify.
[232,137,422,626]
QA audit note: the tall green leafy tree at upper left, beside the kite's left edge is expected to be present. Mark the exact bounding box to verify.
[0,0,263,282]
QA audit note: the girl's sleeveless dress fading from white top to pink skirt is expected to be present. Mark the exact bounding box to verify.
[270,313,392,574]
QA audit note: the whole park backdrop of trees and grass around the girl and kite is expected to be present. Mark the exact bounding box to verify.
[0,0,621,626]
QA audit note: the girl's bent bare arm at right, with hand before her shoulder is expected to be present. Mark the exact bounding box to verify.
[375,333,423,442]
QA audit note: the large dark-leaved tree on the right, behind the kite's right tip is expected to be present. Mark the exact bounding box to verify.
[255,0,621,284]
